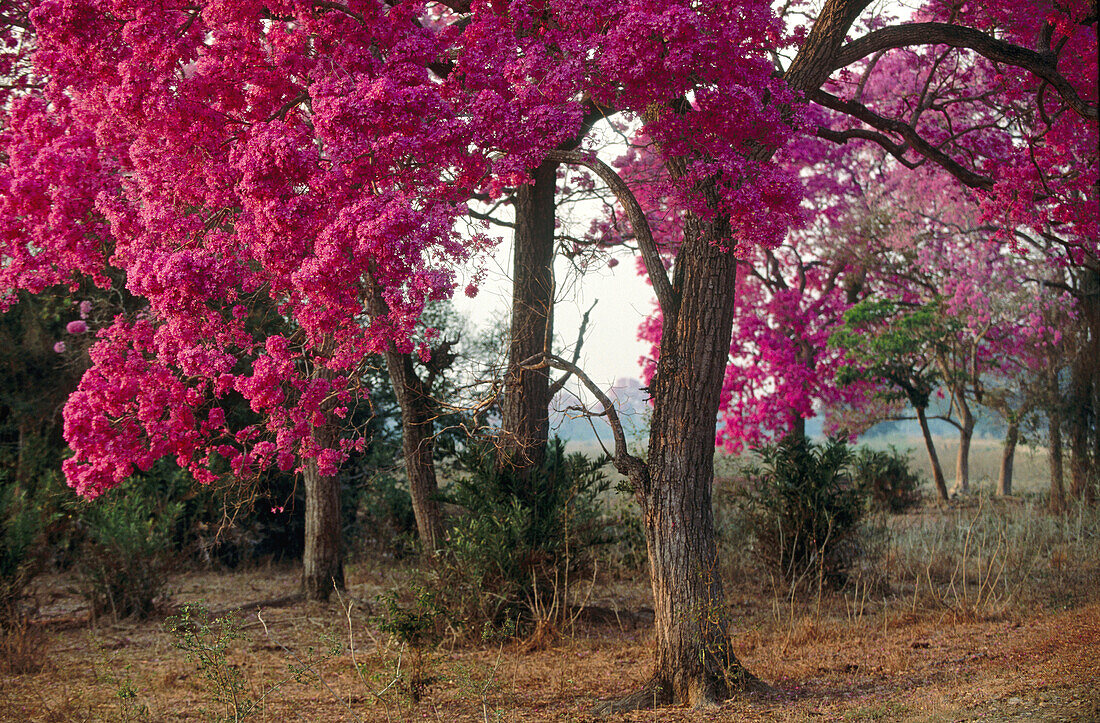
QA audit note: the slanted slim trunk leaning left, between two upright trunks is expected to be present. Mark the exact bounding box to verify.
[385,350,443,557]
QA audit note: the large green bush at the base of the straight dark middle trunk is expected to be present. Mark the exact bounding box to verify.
[440,438,612,624]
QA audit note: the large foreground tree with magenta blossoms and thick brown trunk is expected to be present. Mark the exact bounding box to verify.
[0,0,1097,710]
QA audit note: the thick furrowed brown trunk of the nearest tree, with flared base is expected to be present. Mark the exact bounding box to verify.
[597,212,759,713]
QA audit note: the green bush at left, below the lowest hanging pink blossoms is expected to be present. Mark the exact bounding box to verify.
[76,485,180,620]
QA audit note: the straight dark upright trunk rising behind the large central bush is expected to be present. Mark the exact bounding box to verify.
[501,161,558,474]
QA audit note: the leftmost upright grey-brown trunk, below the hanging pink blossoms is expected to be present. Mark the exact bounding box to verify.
[301,422,344,600]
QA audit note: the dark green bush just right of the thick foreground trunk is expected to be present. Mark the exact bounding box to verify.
[738,436,865,585]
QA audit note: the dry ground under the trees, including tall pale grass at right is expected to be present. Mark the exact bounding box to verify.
[0,502,1100,722]
